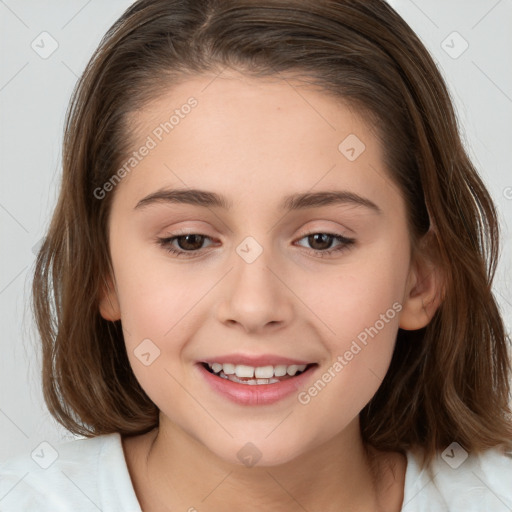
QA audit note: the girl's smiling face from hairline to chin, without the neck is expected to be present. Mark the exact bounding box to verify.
[102,73,422,465]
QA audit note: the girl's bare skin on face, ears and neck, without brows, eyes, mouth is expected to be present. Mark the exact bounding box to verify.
[100,72,440,512]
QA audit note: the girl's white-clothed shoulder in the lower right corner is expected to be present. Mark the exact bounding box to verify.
[402,443,512,512]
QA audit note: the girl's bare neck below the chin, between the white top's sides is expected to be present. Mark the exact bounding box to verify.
[127,418,403,512]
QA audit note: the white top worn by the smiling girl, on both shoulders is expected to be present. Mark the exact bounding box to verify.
[0,433,512,512]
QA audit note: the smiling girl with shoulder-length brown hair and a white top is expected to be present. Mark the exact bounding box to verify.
[0,0,512,512]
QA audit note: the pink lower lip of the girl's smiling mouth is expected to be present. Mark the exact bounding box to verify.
[198,364,316,405]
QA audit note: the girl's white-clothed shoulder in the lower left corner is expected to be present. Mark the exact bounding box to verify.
[0,433,140,512]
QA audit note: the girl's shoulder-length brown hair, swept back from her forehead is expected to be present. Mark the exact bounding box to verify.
[33,0,512,472]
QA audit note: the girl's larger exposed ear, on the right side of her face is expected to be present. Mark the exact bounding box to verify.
[399,233,444,331]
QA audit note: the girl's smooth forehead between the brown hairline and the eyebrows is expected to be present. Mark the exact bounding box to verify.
[113,72,400,212]
